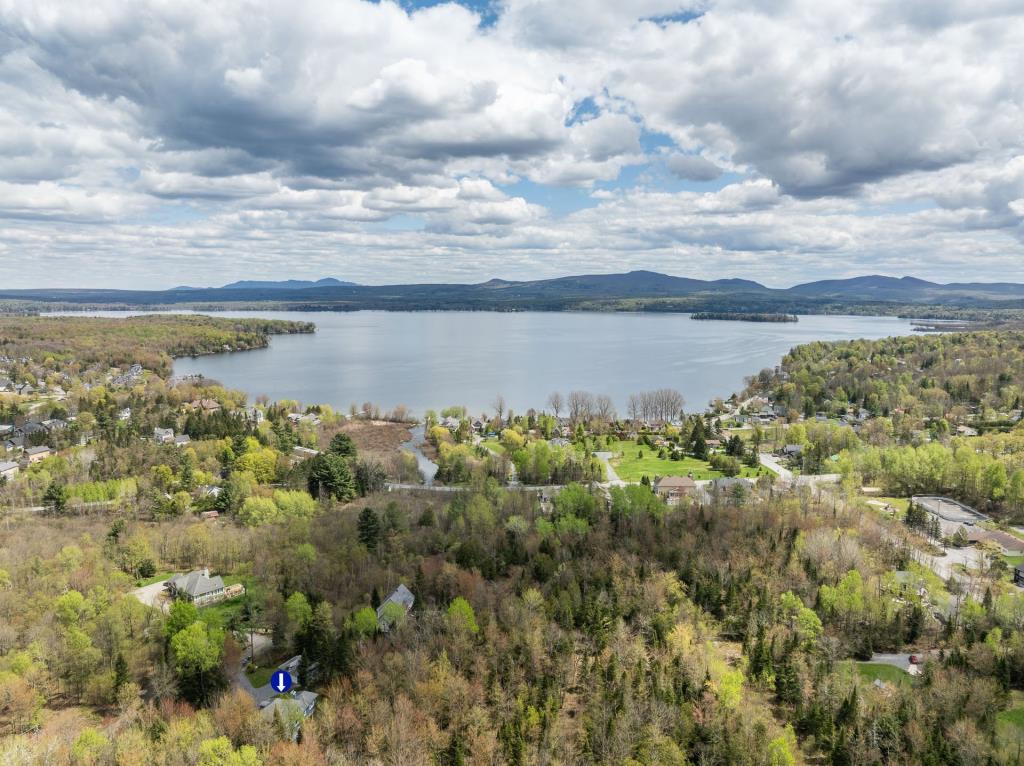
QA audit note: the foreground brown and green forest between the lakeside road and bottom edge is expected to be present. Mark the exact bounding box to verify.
[6,475,1024,764]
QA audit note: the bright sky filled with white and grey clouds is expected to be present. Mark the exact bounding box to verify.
[0,0,1024,289]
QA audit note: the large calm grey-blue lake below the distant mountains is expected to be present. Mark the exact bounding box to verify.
[148,311,911,415]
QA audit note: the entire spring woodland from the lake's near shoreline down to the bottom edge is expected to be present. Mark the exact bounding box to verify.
[6,317,1024,766]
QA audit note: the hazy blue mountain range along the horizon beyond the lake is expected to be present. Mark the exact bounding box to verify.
[6,271,1024,313]
